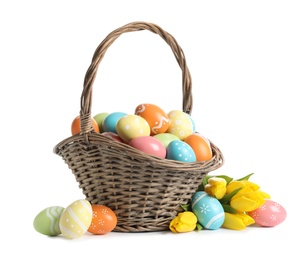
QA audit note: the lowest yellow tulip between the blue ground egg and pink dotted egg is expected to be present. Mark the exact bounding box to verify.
[222,212,255,230]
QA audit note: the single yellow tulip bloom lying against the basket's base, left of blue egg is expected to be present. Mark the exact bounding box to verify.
[169,211,197,233]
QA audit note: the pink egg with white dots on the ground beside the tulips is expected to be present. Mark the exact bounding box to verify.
[248,200,286,227]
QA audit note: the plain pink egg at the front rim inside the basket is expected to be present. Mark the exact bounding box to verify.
[128,136,167,158]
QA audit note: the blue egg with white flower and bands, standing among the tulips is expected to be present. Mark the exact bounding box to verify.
[191,191,225,230]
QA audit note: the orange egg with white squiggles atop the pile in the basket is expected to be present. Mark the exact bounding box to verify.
[135,104,170,135]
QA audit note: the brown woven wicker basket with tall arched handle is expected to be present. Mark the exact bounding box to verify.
[54,22,224,232]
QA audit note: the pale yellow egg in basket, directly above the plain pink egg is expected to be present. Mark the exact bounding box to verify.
[116,114,150,143]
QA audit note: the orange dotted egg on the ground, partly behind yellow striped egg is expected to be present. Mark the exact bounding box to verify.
[88,204,117,235]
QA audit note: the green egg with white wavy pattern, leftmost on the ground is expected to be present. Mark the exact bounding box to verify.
[33,206,65,236]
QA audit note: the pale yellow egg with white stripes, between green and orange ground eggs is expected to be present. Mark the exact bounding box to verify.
[59,199,92,239]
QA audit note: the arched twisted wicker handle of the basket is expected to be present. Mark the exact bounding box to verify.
[80,22,193,133]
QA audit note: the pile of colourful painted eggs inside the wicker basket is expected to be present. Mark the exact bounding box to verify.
[71,103,212,162]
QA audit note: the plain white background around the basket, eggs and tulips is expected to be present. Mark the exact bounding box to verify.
[0,0,300,259]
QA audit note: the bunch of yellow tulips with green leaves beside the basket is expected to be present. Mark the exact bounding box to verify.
[169,173,285,233]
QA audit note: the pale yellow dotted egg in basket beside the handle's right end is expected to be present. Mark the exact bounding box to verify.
[167,110,193,140]
